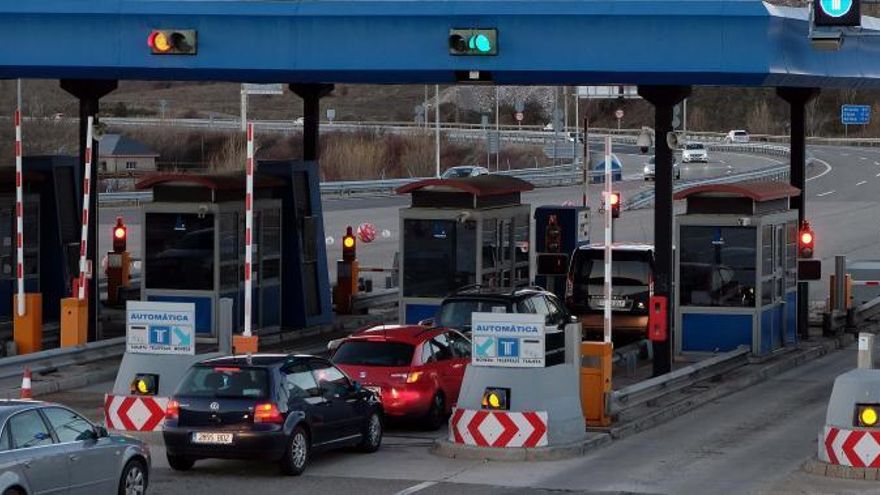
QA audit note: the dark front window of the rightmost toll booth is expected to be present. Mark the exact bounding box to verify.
[678,226,757,307]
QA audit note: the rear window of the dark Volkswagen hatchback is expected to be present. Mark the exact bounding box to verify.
[177,366,269,399]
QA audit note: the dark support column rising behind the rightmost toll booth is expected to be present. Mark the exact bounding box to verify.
[776,87,819,340]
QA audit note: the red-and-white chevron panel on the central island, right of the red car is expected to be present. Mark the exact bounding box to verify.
[449,409,547,448]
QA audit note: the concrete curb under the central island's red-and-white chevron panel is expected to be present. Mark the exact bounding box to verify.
[430,433,611,462]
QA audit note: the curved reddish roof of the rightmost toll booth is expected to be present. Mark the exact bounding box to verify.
[674,181,801,215]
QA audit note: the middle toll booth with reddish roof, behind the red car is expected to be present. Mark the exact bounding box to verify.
[397,175,534,323]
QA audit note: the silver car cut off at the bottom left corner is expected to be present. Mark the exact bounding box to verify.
[0,400,151,495]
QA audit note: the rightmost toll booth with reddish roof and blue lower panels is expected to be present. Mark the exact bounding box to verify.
[674,182,800,355]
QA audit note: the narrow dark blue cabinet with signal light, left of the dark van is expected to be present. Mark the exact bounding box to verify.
[535,206,590,301]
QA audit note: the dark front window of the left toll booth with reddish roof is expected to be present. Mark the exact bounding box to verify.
[144,213,214,290]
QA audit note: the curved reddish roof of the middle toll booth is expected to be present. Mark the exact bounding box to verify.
[396,175,535,209]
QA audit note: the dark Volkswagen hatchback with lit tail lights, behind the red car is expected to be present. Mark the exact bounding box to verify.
[163,354,382,475]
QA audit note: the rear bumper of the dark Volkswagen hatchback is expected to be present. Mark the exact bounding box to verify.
[162,426,287,460]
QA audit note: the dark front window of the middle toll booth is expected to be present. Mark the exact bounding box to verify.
[403,220,476,297]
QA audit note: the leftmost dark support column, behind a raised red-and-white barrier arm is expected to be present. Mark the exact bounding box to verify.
[61,79,118,341]
